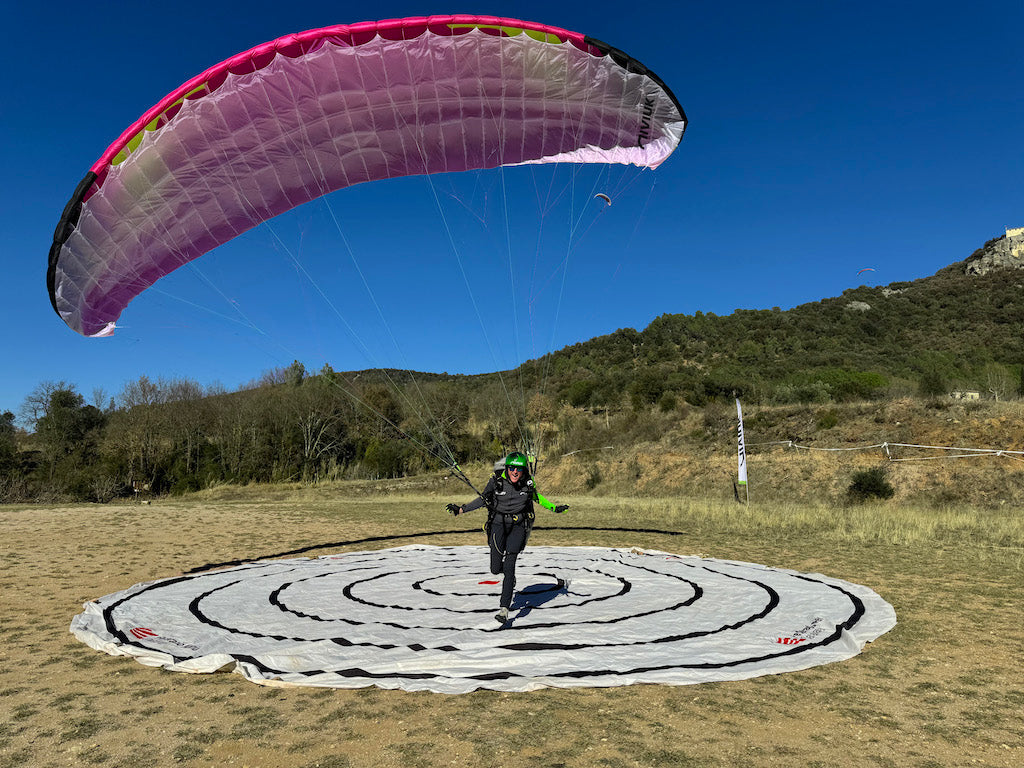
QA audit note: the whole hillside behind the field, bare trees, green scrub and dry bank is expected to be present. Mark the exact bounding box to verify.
[8,230,1024,505]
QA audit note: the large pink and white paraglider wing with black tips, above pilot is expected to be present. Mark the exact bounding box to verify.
[47,15,686,336]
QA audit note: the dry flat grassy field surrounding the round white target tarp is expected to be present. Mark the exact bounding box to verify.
[0,485,1024,768]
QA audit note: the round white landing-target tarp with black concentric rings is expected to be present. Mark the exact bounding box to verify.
[71,545,896,693]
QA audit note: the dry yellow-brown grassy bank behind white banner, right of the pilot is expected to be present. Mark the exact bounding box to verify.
[544,398,1024,507]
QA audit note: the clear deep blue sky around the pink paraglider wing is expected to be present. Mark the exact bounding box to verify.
[0,0,1024,421]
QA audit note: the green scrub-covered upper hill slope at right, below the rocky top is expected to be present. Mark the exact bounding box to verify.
[545,225,1024,406]
